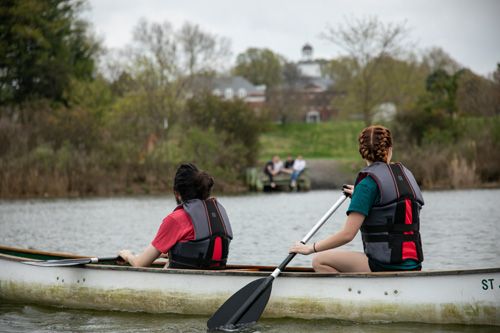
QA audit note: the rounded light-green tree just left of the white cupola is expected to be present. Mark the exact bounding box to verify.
[233,48,285,88]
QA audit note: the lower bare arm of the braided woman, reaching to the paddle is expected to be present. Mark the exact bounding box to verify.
[290,212,365,254]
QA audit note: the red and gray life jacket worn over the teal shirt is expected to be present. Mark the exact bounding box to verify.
[356,162,424,264]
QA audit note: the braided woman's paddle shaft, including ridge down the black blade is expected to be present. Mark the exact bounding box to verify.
[227,195,347,325]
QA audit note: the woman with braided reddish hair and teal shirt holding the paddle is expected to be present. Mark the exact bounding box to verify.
[290,126,424,272]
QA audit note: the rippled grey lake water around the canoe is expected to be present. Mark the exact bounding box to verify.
[0,190,500,333]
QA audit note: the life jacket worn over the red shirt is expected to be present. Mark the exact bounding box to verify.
[169,198,233,269]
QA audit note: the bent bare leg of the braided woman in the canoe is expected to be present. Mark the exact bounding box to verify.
[312,250,371,273]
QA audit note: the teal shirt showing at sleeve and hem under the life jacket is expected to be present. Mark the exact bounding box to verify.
[347,176,420,270]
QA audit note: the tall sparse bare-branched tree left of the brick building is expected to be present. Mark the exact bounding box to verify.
[117,20,230,136]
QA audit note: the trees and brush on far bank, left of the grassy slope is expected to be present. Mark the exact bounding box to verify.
[0,0,263,197]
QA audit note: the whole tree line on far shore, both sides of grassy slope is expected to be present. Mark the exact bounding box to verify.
[0,0,500,197]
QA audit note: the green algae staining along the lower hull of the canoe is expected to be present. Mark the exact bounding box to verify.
[0,281,500,325]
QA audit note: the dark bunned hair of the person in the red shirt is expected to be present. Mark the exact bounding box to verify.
[174,163,214,201]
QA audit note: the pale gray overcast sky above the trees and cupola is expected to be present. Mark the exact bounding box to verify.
[86,0,500,75]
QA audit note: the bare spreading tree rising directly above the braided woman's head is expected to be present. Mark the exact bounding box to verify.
[321,17,409,124]
